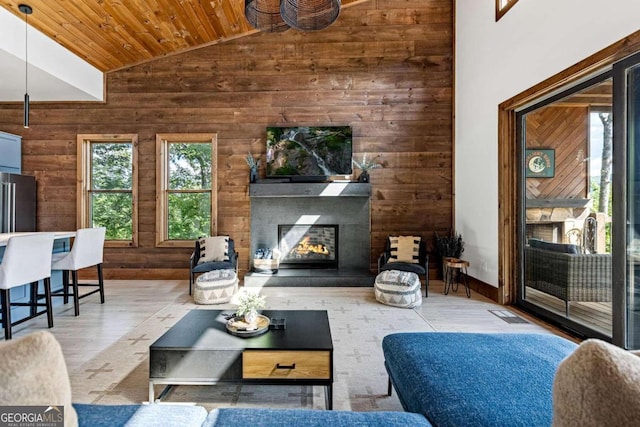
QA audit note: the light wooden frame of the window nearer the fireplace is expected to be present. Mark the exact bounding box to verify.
[156,133,218,248]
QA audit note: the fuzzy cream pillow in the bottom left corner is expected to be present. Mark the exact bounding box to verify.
[0,331,78,427]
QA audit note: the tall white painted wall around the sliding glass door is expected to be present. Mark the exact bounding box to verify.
[455,0,640,287]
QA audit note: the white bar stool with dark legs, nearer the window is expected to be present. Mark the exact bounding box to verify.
[51,227,106,316]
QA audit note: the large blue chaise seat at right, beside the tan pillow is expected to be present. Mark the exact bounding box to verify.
[382,332,577,427]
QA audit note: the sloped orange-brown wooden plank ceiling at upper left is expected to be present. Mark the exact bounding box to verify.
[0,0,363,72]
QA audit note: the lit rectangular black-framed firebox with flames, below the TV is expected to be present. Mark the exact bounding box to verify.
[278,224,338,269]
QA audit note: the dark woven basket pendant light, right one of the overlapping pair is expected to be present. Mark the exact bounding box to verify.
[280,0,341,31]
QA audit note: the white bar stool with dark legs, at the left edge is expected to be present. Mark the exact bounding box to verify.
[0,233,55,340]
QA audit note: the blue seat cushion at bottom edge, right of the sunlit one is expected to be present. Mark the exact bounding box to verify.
[202,408,431,427]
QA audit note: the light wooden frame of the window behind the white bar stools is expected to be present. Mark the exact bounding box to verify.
[76,134,138,248]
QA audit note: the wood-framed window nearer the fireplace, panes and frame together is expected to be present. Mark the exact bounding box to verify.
[156,134,218,247]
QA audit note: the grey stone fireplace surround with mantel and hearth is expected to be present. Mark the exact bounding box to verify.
[244,180,374,286]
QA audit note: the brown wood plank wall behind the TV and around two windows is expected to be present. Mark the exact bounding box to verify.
[0,0,453,279]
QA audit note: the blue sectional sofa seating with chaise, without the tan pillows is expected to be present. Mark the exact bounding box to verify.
[74,332,577,427]
